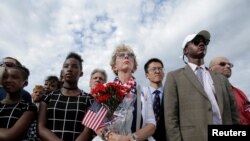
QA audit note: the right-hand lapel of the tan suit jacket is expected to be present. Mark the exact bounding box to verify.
[210,71,223,114]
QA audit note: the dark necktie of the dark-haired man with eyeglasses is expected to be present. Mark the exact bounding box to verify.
[153,90,161,122]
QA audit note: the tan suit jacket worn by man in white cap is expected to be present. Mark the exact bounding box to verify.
[164,65,239,141]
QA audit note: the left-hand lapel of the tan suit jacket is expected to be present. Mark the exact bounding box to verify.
[184,65,208,99]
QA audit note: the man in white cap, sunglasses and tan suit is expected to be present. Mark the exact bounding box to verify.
[164,30,239,141]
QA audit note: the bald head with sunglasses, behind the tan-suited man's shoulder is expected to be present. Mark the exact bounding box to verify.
[209,57,233,78]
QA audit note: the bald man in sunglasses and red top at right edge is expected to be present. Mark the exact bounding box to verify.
[209,57,250,125]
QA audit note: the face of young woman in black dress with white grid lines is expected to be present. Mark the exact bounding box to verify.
[62,58,82,82]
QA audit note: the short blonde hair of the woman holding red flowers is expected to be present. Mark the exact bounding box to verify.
[110,44,138,75]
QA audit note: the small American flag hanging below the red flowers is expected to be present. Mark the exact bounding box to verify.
[82,102,108,131]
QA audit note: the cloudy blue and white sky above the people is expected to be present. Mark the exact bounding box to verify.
[0,0,250,98]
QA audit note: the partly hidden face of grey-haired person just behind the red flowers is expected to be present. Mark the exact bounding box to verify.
[89,72,105,89]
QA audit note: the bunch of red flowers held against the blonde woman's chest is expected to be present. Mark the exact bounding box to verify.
[91,82,129,114]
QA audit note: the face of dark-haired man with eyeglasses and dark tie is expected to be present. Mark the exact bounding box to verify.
[146,62,164,84]
